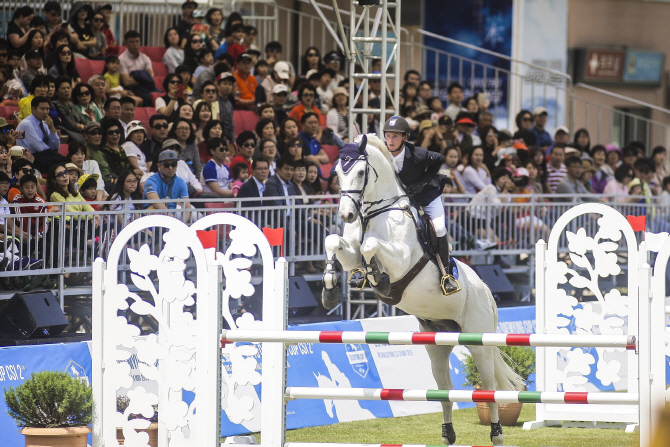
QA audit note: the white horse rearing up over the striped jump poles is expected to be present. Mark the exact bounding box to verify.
[322,135,525,445]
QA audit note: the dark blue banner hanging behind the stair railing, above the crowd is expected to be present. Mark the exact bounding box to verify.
[422,0,513,121]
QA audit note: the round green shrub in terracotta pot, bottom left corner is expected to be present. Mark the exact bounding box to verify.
[5,371,93,447]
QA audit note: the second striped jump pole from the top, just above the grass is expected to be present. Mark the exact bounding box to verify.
[285,387,639,405]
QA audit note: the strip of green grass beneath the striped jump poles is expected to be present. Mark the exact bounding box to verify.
[286,404,639,447]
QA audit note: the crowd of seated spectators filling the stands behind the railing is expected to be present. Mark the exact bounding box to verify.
[0,1,670,276]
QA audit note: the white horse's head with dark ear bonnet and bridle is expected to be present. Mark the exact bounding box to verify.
[335,135,370,223]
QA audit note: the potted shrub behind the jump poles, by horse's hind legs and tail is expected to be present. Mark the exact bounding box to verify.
[463,346,535,426]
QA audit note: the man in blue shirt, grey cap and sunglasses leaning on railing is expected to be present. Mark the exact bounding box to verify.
[142,149,192,222]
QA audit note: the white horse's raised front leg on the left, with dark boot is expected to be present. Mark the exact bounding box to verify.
[321,234,361,309]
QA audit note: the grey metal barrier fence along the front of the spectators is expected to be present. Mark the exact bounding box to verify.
[0,195,670,288]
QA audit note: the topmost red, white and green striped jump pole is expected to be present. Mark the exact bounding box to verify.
[221,329,636,350]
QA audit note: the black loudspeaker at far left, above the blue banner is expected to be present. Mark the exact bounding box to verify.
[0,291,68,338]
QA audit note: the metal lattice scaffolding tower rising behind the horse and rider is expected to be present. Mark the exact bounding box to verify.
[310,0,401,141]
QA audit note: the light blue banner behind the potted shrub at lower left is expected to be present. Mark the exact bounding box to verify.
[0,342,91,447]
